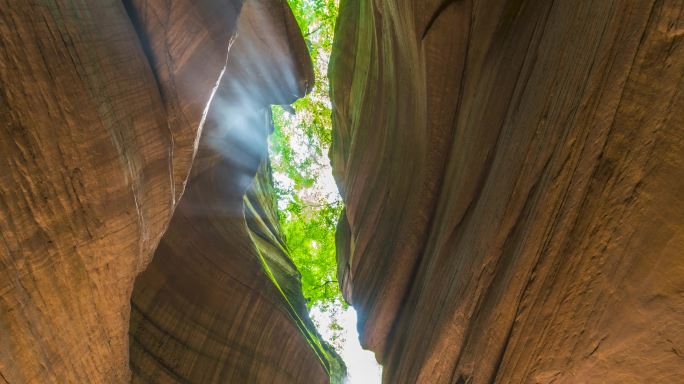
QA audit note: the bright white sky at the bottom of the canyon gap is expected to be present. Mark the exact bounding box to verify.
[310,306,382,384]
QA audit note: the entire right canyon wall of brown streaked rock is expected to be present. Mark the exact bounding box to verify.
[330,0,684,383]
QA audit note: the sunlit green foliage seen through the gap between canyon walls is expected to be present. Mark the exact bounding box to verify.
[271,0,344,308]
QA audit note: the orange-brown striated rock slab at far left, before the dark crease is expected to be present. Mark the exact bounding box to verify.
[0,0,187,383]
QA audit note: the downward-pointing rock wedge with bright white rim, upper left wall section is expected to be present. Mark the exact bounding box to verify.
[123,0,242,199]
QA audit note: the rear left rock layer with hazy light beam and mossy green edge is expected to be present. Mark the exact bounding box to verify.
[130,1,344,383]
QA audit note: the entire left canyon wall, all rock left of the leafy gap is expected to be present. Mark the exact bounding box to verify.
[0,0,343,384]
